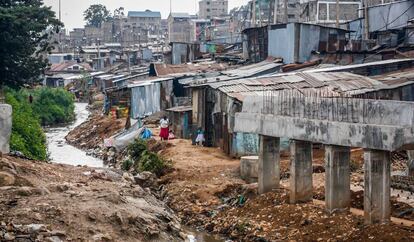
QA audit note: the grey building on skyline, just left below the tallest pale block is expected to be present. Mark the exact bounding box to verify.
[168,13,193,43]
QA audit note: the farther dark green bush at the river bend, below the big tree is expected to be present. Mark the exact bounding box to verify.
[31,87,75,125]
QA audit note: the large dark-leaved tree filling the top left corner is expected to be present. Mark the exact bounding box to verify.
[0,0,63,89]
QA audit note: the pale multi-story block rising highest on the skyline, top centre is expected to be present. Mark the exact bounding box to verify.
[199,0,229,19]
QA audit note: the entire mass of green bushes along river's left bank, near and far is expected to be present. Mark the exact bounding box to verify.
[6,88,74,160]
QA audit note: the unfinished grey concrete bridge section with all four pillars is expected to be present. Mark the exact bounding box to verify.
[235,92,414,224]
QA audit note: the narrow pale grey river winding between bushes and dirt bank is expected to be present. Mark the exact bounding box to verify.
[45,103,104,167]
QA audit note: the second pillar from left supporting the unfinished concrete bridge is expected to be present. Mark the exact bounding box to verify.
[290,140,313,203]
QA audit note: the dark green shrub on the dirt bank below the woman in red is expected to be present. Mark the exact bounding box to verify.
[126,139,169,176]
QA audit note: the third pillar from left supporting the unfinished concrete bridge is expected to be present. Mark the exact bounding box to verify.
[325,145,351,213]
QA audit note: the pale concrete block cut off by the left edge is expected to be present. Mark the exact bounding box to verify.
[0,104,12,154]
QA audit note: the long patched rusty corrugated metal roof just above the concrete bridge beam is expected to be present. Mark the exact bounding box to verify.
[208,71,414,101]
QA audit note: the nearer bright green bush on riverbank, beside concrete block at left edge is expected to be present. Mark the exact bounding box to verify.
[6,90,47,160]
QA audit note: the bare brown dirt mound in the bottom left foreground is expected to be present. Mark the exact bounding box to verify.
[0,156,185,241]
